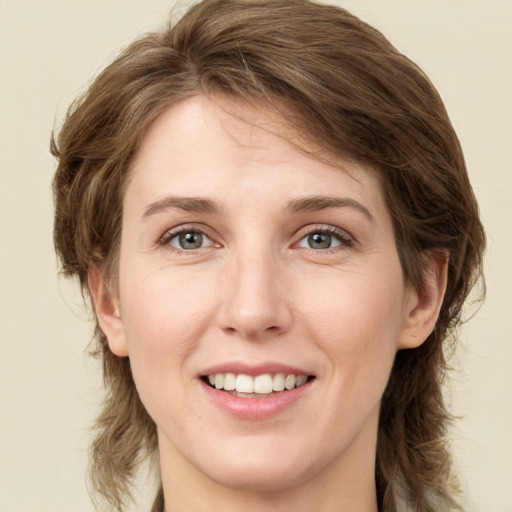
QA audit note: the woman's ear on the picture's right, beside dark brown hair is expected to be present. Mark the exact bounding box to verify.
[398,252,448,349]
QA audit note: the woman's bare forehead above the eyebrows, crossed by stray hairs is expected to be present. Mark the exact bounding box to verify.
[128,96,382,210]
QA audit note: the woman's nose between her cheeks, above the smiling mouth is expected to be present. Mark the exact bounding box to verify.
[219,251,292,340]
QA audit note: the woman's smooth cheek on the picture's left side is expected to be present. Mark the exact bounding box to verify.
[121,269,215,378]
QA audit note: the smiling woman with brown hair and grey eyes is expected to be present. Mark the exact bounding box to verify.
[52,0,484,512]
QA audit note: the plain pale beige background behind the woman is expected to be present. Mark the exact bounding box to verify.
[0,0,512,512]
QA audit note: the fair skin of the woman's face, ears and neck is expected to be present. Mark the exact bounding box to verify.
[89,96,446,512]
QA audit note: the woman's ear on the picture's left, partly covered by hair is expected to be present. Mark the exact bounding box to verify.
[88,264,128,357]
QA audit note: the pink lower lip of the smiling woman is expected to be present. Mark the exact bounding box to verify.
[199,379,314,420]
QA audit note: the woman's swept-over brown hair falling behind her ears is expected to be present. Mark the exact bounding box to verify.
[52,0,485,511]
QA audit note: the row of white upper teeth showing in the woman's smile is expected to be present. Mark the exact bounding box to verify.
[208,373,308,395]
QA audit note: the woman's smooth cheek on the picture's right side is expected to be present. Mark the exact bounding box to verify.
[303,269,404,390]
